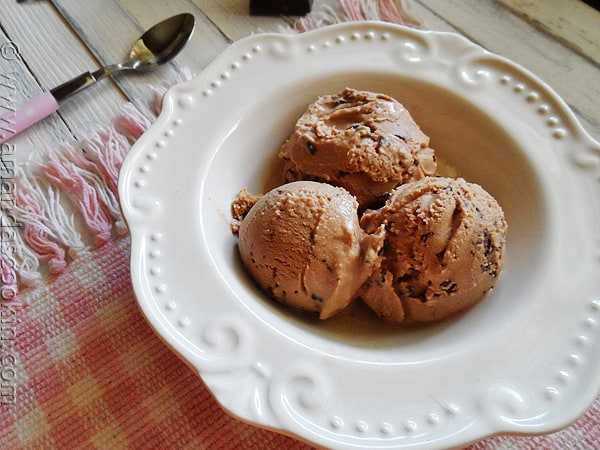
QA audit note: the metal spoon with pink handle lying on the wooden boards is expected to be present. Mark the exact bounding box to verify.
[0,13,196,144]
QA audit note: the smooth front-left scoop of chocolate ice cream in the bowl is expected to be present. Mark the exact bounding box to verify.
[238,181,383,319]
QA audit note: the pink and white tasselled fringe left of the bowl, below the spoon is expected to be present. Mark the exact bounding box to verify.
[0,103,159,294]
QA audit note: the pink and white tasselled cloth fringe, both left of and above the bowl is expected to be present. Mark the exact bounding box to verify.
[0,0,419,298]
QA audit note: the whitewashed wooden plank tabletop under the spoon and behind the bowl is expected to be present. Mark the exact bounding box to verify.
[0,0,600,446]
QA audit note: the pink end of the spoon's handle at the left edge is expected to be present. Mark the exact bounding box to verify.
[0,92,58,144]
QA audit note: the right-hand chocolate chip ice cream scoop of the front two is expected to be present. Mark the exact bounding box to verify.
[359,177,507,323]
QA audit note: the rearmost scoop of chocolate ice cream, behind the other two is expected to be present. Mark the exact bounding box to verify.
[279,88,436,207]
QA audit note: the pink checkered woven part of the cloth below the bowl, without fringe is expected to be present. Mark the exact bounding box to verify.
[0,238,600,450]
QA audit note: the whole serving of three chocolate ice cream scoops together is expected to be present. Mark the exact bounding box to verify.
[231,88,507,324]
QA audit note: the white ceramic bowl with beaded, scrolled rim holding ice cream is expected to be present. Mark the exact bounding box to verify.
[119,22,600,449]
